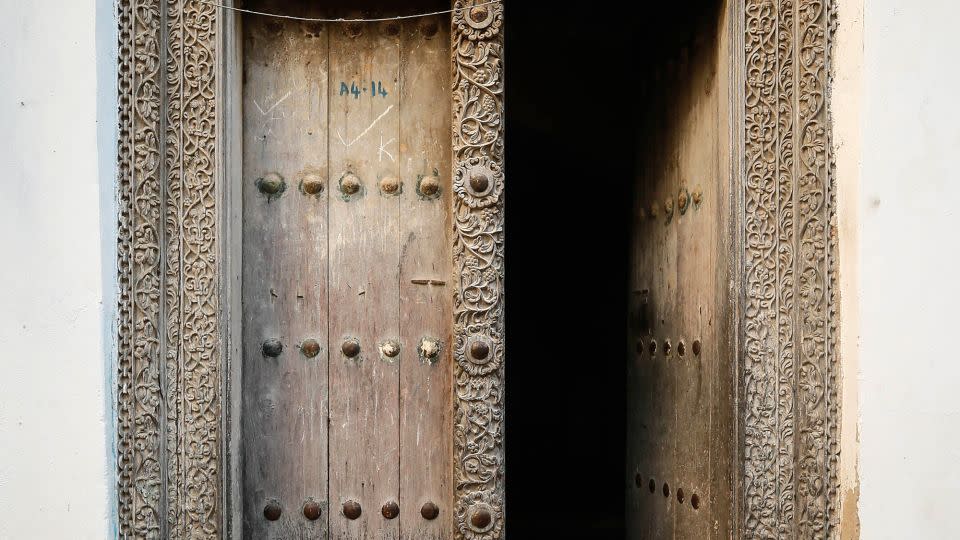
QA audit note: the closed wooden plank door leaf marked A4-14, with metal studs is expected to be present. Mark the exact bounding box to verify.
[240,2,453,539]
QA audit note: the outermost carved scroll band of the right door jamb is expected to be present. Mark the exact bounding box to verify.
[796,0,838,538]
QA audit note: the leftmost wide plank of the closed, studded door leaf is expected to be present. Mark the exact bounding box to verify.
[235,13,328,539]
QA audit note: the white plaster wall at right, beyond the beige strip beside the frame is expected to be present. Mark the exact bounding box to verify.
[858,0,960,540]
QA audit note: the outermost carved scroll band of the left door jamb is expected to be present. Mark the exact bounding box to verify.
[125,2,164,538]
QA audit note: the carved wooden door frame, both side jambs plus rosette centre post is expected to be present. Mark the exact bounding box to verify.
[117,0,839,540]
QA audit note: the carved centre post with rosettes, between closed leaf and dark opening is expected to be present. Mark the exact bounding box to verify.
[452,0,504,540]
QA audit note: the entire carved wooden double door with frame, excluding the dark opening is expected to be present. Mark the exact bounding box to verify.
[116,0,842,540]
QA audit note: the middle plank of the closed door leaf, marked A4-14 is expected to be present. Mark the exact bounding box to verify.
[329,17,400,539]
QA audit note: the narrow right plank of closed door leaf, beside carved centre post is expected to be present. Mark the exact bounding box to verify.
[399,16,453,540]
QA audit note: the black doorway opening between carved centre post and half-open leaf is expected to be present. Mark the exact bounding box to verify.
[505,1,718,539]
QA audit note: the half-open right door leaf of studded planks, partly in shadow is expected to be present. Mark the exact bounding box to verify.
[627,13,739,540]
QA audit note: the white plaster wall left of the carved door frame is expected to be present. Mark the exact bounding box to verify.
[0,0,116,540]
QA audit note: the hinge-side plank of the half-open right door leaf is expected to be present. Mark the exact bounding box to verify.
[674,35,722,538]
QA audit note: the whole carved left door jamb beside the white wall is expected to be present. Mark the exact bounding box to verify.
[117,0,222,538]
